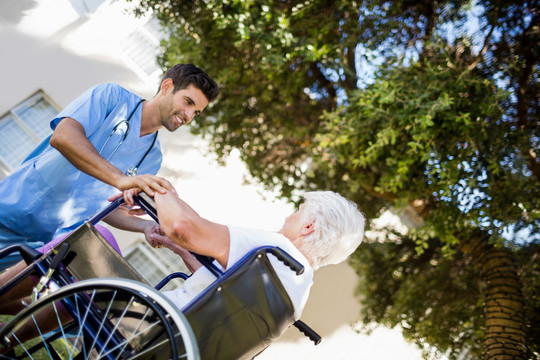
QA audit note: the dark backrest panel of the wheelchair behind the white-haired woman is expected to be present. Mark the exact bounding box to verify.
[183,248,295,360]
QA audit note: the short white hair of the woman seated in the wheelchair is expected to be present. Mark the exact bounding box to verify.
[300,191,365,269]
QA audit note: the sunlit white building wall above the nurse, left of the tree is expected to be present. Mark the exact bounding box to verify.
[0,0,156,118]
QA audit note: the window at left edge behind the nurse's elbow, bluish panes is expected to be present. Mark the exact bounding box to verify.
[0,91,59,174]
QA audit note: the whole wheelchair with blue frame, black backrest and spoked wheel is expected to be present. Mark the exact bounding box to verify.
[0,194,321,360]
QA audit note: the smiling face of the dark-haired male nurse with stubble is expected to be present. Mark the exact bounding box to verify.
[159,85,208,131]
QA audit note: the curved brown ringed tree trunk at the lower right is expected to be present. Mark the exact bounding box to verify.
[459,234,528,360]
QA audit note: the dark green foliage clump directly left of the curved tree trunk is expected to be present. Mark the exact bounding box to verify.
[351,238,485,358]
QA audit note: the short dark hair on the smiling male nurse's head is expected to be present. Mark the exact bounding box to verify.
[158,64,219,102]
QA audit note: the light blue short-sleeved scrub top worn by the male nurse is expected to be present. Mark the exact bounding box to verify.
[0,84,162,247]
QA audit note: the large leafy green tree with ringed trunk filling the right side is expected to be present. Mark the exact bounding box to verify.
[132,0,540,359]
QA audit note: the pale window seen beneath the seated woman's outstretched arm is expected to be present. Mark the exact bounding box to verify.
[125,241,190,290]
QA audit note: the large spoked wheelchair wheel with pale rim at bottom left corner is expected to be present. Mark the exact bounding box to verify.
[0,279,200,360]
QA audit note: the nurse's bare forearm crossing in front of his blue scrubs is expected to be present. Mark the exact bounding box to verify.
[49,118,126,188]
